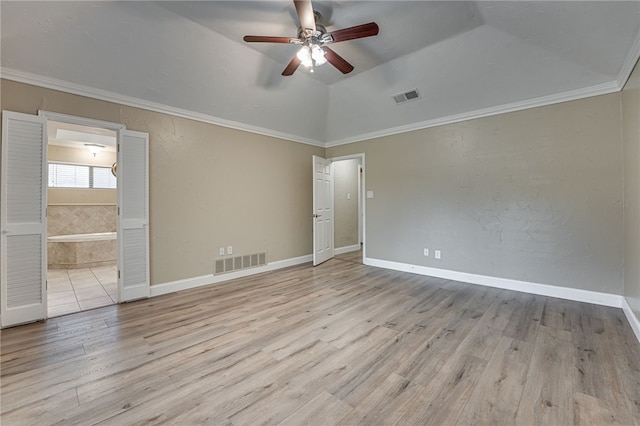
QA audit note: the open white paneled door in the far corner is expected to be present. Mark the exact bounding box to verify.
[313,155,334,266]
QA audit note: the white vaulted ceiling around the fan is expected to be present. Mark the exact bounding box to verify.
[0,0,640,145]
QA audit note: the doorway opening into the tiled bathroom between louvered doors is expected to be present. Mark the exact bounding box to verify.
[47,119,118,317]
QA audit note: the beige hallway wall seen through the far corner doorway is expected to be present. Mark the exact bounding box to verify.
[333,159,360,248]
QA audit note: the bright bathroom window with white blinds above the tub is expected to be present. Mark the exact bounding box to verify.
[49,163,116,189]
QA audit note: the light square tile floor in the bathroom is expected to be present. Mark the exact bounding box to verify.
[47,265,118,317]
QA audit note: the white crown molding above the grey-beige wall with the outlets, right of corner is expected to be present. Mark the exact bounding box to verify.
[326,81,622,148]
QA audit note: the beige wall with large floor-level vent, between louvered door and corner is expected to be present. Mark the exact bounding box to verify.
[2,80,324,285]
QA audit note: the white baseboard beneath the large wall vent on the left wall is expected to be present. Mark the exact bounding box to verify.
[150,255,313,297]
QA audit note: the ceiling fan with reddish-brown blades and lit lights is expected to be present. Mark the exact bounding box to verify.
[243,0,378,76]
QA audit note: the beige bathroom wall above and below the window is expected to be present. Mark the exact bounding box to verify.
[47,145,117,205]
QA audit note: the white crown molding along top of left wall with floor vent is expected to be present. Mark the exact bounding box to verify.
[0,67,325,148]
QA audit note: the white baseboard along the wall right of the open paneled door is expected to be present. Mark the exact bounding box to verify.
[364,258,623,308]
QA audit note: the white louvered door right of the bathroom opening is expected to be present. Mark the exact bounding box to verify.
[117,129,150,302]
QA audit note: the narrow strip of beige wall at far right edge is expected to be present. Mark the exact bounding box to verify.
[622,60,640,320]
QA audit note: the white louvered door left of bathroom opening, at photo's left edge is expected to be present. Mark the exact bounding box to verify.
[0,111,47,327]
